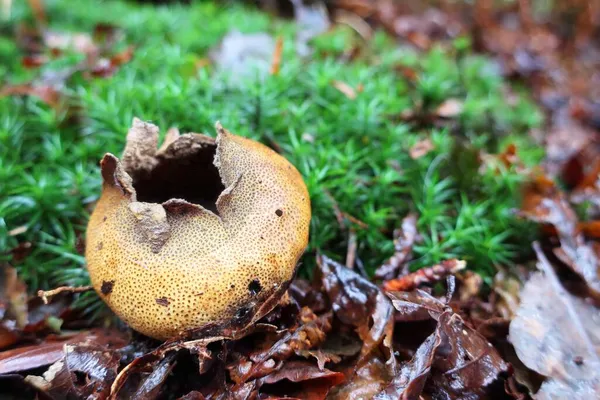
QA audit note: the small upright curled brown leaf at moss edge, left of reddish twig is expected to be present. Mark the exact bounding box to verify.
[375,214,419,280]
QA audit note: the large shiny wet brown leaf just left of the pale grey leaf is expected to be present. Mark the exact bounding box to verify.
[386,282,508,399]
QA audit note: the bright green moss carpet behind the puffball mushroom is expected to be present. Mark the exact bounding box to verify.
[0,0,543,301]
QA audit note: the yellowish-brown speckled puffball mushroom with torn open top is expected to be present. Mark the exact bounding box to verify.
[85,118,311,340]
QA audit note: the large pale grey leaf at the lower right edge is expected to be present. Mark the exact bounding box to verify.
[510,247,600,400]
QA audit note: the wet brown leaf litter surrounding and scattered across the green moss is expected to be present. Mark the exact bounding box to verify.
[0,0,600,399]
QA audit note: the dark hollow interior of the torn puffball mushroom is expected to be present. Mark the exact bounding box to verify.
[128,145,225,213]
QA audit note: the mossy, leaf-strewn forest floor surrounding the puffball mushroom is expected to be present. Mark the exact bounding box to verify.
[0,0,600,399]
